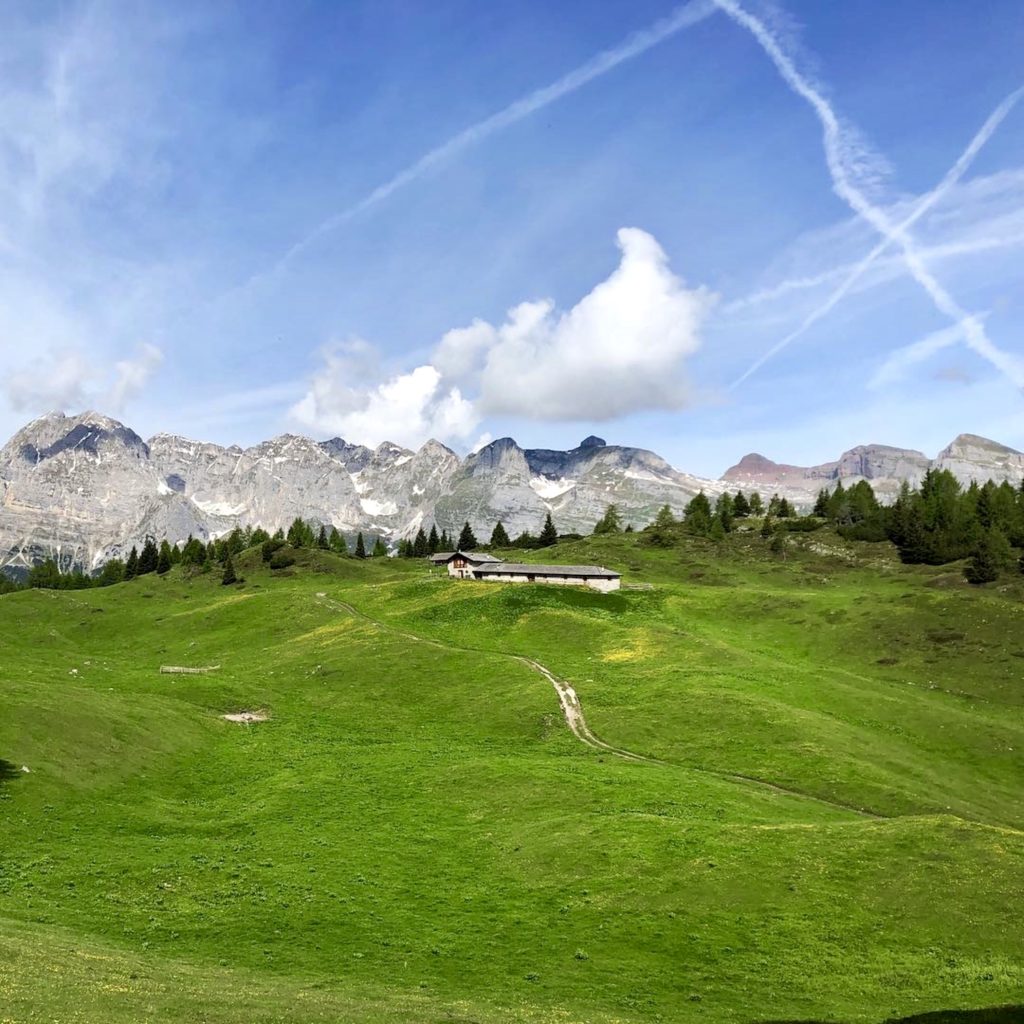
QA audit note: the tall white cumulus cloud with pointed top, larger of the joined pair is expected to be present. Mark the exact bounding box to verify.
[468,227,715,420]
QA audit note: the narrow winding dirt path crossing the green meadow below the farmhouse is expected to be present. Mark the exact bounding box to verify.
[316,593,888,819]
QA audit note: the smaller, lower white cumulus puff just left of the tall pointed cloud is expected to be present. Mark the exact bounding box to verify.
[291,342,479,446]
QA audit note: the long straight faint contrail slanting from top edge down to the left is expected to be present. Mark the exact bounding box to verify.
[262,0,715,274]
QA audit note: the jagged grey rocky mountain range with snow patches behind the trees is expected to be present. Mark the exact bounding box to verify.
[0,412,1024,574]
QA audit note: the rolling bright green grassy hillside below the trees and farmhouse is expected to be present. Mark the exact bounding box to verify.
[0,534,1024,1022]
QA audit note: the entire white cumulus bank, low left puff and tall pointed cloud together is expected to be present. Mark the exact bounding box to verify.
[291,228,715,445]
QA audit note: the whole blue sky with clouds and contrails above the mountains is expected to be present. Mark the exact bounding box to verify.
[0,0,1024,476]
